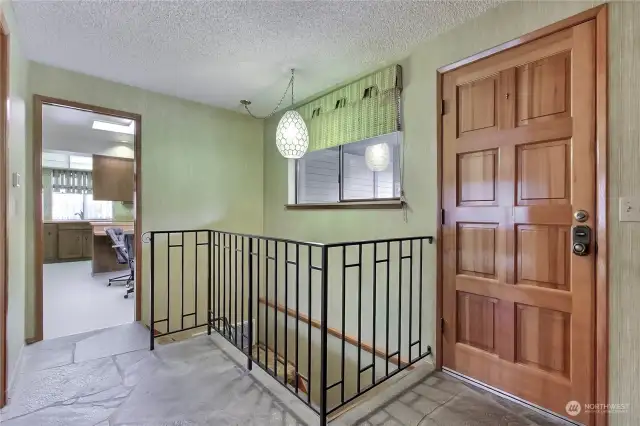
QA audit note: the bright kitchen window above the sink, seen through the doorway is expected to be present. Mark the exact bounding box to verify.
[51,192,113,220]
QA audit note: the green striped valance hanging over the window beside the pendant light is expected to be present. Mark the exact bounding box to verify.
[297,65,402,151]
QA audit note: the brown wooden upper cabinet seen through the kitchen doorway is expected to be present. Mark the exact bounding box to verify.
[93,155,134,202]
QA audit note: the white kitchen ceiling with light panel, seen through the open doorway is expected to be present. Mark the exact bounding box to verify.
[42,105,133,154]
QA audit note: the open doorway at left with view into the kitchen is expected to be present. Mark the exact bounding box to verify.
[33,95,141,341]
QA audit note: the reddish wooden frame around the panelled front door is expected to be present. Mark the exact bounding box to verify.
[435,4,609,426]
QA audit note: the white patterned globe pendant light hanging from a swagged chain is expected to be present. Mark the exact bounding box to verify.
[240,69,309,158]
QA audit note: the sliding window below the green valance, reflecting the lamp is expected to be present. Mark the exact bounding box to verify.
[295,133,401,204]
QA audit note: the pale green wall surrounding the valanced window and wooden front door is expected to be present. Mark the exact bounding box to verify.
[264,1,640,426]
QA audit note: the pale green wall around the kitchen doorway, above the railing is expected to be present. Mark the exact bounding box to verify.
[25,63,263,342]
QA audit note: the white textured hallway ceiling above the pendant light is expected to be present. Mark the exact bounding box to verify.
[13,0,503,114]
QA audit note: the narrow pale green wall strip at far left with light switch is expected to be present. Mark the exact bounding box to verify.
[0,0,29,390]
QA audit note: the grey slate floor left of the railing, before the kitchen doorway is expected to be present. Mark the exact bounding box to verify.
[0,324,307,426]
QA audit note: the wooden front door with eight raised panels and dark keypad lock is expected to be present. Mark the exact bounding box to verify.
[442,21,596,423]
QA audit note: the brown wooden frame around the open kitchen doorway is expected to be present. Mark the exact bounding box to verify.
[27,94,142,343]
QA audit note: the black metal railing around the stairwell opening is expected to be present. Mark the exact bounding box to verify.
[147,230,433,425]
